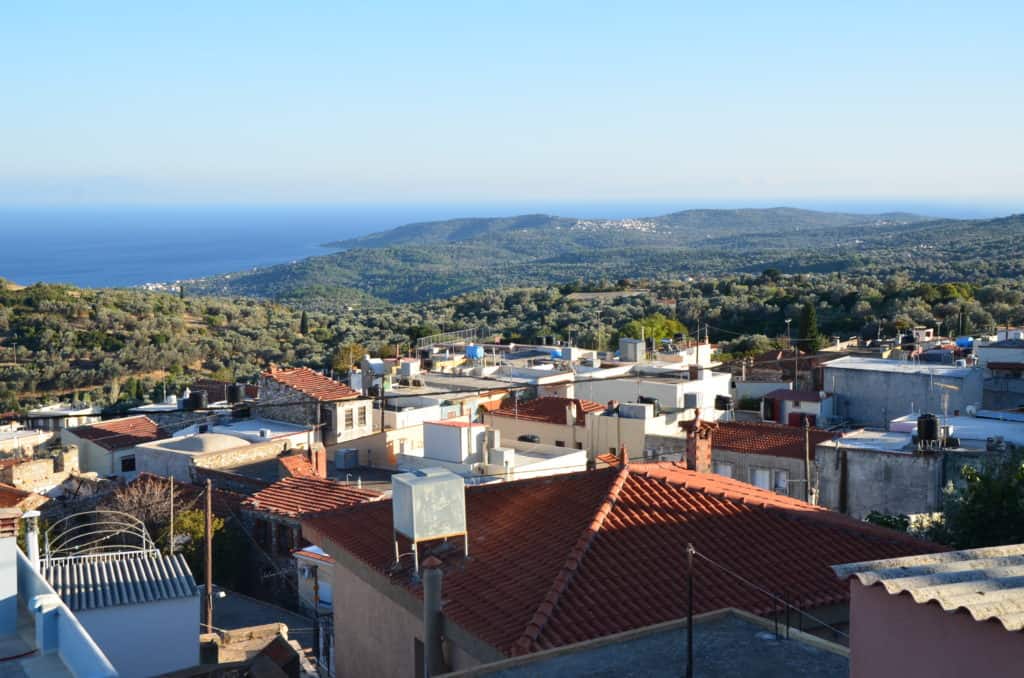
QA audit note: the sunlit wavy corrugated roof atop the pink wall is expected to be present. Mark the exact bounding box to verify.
[833,544,1024,631]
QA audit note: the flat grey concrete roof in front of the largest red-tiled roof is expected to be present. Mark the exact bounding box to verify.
[452,610,850,678]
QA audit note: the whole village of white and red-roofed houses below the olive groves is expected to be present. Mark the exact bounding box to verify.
[0,319,1024,678]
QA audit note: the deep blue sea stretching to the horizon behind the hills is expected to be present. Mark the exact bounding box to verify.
[0,201,1005,287]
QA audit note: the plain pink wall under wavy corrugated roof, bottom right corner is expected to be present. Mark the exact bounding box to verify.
[850,579,1024,678]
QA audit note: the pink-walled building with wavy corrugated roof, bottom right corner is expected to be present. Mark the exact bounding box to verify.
[833,544,1024,678]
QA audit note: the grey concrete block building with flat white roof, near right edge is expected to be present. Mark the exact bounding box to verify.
[823,356,983,428]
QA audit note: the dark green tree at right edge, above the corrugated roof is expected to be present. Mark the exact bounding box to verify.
[929,453,1024,549]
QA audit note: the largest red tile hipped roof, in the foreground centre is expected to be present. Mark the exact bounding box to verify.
[303,464,941,655]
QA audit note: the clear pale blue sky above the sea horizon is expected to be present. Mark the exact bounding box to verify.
[0,0,1024,204]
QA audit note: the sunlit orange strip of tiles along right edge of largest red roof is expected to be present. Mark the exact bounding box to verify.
[641,462,948,551]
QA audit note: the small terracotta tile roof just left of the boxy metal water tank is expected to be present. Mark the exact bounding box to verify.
[242,477,380,518]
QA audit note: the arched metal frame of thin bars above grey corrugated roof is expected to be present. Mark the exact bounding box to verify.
[44,510,157,563]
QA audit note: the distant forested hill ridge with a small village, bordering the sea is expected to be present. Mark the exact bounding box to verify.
[187,208,1024,310]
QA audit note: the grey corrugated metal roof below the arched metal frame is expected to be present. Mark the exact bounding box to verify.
[41,552,199,611]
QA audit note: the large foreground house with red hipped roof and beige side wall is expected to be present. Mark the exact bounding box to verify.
[302,464,938,678]
